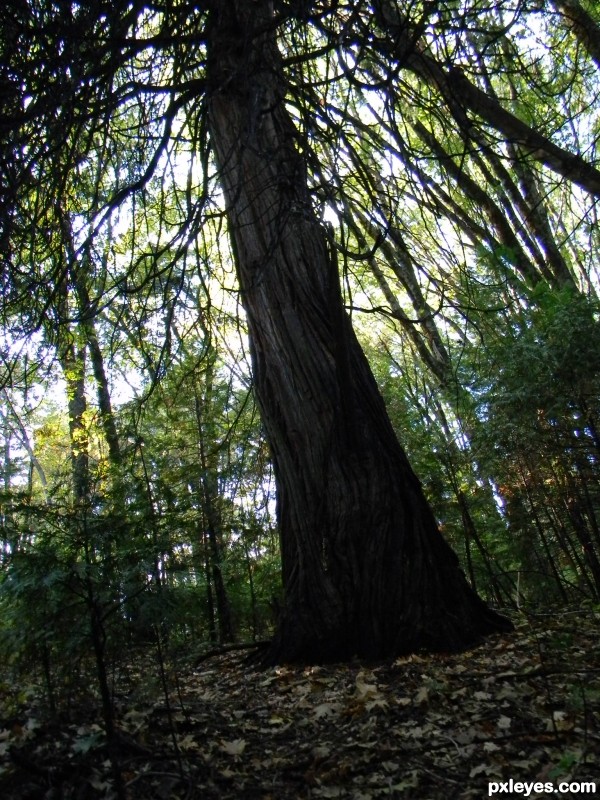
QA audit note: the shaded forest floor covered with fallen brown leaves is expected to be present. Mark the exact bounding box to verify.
[0,608,600,800]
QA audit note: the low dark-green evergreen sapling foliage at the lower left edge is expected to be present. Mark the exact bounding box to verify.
[0,505,114,712]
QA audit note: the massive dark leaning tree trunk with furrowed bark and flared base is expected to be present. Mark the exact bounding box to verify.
[208,0,510,663]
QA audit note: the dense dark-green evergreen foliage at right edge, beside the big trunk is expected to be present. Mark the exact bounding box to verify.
[464,283,600,600]
